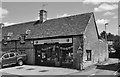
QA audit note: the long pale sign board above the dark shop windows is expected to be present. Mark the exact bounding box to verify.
[34,38,72,45]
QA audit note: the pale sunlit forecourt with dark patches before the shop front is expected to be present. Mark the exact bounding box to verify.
[0,65,79,75]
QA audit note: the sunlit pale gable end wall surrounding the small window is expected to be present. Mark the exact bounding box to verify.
[83,16,108,68]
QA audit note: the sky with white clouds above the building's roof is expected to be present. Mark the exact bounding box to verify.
[0,0,118,35]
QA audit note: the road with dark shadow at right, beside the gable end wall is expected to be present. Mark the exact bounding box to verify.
[72,59,120,77]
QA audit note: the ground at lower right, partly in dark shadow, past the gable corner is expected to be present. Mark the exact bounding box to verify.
[71,59,120,76]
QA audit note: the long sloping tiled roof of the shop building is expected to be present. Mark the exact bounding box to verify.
[2,12,93,39]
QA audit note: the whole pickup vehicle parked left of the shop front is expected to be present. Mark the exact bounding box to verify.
[0,52,27,68]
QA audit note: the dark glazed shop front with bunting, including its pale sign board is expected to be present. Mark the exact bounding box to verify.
[34,38,73,68]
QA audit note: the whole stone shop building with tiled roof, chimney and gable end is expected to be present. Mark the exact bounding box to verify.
[2,10,108,69]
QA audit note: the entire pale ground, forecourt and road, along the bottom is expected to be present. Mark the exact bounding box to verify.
[0,59,120,77]
